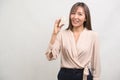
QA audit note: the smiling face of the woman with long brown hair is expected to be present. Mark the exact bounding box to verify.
[70,7,86,27]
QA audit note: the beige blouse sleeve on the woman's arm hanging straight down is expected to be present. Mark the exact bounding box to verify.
[92,33,100,80]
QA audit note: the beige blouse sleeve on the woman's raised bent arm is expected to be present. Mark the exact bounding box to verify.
[45,32,61,61]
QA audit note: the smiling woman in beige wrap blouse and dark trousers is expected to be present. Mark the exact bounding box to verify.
[46,2,100,80]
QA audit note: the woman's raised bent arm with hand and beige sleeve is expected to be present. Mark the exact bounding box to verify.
[46,19,63,60]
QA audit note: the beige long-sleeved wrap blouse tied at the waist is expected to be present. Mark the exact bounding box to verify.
[46,28,100,80]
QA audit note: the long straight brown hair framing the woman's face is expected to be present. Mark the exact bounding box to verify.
[66,2,92,30]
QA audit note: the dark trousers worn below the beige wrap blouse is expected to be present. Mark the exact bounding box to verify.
[57,68,93,80]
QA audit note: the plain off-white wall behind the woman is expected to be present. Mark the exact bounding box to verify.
[0,0,120,80]
